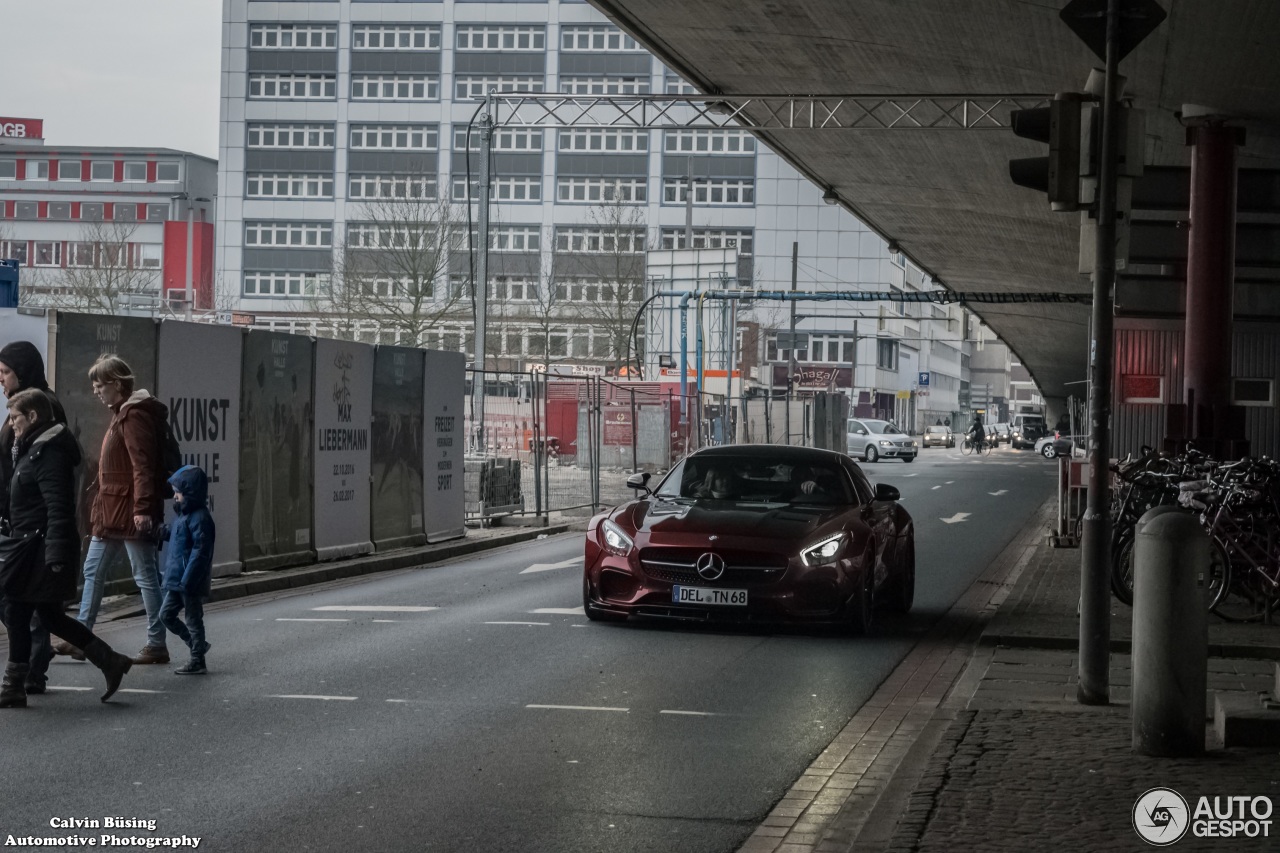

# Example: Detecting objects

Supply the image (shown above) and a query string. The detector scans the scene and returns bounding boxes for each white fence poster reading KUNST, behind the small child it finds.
[155,320,244,578]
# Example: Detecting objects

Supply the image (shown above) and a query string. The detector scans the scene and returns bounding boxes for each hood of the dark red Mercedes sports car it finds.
[616,500,858,543]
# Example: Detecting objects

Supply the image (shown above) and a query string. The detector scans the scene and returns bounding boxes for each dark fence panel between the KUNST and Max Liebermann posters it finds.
[241,329,315,570]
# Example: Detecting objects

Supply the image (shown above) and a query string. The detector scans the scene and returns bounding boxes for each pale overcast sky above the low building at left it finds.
[0,0,223,158]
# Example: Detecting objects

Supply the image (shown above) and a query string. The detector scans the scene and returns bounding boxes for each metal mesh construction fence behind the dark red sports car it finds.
[465,370,844,520]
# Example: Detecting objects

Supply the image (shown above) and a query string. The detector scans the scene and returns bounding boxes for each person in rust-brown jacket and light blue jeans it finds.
[54,355,169,663]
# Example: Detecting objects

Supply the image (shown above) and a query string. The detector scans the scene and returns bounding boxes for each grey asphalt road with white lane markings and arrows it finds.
[0,440,1056,853]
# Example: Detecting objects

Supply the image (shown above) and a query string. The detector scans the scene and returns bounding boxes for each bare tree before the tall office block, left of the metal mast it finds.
[320,183,467,346]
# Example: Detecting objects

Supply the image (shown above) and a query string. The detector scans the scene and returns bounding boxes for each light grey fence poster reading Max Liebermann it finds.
[314,338,374,560]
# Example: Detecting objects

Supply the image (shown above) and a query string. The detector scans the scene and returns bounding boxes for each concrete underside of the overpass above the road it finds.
[590,0,1280,407]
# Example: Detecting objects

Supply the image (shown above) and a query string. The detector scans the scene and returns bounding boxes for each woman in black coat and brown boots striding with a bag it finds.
[0,388,133,708]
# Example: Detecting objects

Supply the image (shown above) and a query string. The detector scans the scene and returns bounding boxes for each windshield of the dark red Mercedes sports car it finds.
[657,455,854,506]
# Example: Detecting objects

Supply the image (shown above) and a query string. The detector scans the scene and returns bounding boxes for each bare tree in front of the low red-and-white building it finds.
[24,222,160,314]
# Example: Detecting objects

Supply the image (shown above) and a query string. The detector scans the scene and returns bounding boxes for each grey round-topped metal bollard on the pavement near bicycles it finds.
[1130,506,1210,757]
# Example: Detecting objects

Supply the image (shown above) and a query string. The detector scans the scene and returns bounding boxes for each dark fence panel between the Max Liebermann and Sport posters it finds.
[370,346,426,551]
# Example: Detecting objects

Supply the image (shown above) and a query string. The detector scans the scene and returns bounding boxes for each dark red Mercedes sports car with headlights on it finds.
[582,444,915,634]
